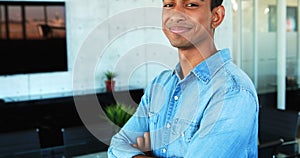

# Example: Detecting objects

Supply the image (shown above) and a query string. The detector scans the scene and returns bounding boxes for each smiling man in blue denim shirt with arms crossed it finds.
[108,0,259,158]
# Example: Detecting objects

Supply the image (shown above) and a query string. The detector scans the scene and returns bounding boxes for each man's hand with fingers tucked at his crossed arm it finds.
[132,132,152,156]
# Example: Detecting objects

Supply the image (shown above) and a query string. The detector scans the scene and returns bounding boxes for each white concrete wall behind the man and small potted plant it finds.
[0,0,232,101]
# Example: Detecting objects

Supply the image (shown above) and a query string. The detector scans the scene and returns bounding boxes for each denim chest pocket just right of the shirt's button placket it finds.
[172,118,199,143]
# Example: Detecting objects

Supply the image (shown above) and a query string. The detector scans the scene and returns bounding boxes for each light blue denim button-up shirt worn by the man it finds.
[108,49,259,158]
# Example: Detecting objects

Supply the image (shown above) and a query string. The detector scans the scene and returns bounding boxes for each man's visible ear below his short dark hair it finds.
[211,5,225,29]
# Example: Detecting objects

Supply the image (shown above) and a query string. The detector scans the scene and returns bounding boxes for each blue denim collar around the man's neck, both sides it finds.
[174,48,231,83]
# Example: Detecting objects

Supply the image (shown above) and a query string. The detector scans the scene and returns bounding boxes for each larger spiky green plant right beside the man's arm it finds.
[105,103,135,127]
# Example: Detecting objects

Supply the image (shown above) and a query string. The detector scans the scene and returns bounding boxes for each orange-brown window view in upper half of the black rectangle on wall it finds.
[0,2,66,39]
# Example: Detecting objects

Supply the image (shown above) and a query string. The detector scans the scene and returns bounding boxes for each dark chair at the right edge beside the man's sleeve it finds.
[259,107,298,157]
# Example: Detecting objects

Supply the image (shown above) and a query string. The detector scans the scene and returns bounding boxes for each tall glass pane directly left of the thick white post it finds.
[257,0,277,93]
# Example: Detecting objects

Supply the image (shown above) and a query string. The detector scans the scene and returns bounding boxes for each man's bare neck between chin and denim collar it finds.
[178,45,217,78]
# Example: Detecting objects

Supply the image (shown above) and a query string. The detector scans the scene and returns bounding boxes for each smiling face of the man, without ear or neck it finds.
[162,0,213,49]
